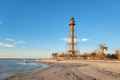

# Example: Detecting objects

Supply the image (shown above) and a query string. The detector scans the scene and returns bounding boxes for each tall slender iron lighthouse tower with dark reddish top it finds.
[68,17,77,57]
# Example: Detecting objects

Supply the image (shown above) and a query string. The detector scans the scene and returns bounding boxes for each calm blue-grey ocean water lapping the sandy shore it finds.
[0,59,47,80]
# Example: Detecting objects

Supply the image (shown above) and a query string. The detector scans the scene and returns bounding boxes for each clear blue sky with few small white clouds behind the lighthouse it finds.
[0,0,120,58]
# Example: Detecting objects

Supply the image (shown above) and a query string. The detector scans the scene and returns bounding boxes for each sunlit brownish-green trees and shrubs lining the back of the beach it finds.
[52,44,120,60]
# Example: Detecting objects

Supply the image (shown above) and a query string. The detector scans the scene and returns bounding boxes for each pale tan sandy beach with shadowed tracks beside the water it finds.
[8,60,120,80]
